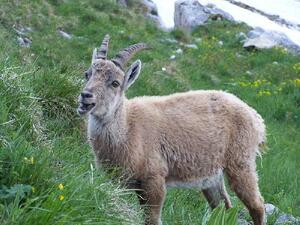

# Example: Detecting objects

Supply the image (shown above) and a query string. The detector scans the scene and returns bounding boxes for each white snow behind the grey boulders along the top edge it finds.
[153,0,300,46]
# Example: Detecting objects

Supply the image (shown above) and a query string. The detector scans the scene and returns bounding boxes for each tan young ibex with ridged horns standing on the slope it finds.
[78,35,265,225]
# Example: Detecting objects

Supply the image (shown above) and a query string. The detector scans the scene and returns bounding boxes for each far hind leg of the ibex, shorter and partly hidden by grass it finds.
[202,178,232,209]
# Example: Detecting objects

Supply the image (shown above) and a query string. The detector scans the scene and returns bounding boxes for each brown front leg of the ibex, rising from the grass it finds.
[140,176,166,225]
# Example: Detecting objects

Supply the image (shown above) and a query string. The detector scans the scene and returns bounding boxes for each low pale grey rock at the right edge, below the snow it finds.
[243,28,300,54]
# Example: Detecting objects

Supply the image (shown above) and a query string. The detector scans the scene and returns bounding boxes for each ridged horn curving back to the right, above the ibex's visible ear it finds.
[111,43,149,70]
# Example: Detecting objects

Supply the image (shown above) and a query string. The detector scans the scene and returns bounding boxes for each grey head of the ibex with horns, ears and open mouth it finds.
[77,35,148,117]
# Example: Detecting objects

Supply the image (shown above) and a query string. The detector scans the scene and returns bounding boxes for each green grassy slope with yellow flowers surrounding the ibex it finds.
[0,0,300,224]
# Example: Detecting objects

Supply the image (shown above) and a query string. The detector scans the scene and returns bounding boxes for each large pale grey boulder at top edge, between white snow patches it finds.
[174,0,233,31]
